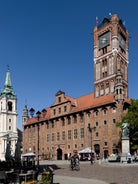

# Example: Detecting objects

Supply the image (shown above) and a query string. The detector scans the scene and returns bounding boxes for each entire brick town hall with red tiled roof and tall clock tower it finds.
[22,14,130,159]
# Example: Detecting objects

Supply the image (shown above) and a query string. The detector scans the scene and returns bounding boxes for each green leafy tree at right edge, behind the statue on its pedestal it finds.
[118,99,138,151]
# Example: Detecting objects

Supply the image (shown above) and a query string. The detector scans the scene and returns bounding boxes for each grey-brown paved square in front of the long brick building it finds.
[41,161,138,184]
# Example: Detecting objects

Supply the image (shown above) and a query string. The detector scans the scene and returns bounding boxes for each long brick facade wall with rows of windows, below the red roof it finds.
[24,98,128,159]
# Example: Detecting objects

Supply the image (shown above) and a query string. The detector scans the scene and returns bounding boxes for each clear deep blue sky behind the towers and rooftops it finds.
[0,0,138,128]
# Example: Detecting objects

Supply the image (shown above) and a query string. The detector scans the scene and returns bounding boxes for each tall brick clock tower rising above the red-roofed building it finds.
[93,14,129,101]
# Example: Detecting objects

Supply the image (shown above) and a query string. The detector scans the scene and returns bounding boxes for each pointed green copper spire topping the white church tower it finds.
[1,68,16,97]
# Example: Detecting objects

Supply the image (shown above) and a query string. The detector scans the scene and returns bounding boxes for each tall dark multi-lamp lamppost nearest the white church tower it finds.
[29,108,41,168]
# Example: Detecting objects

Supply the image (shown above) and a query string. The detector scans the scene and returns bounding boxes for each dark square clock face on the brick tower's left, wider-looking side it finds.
[98,31,110,49]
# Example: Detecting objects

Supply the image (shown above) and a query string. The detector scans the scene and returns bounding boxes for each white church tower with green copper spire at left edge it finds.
[0,68,18,160]
